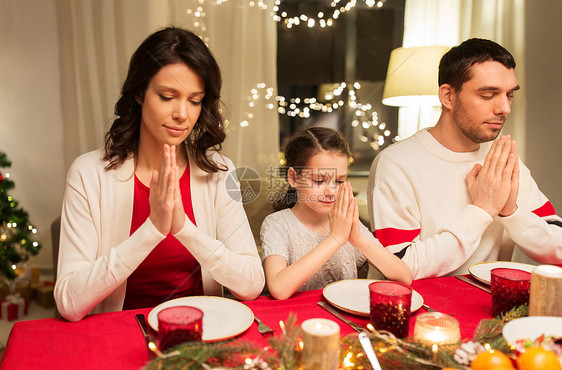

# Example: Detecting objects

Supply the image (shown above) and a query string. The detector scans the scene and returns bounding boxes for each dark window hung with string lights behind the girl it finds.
[277,0,405,172]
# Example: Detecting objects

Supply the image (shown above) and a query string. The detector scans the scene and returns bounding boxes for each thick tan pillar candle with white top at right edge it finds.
[529,265,562,316]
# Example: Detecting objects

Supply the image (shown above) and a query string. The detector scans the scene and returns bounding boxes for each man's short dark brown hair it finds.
[439,38,515,91]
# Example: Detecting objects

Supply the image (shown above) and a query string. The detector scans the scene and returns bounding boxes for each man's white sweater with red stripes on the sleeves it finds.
[367,129,562,279]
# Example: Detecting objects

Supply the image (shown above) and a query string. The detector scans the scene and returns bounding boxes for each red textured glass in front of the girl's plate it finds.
[369,281,412,338]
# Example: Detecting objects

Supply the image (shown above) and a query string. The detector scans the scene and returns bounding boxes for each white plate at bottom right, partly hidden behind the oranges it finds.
[502,316,562,345]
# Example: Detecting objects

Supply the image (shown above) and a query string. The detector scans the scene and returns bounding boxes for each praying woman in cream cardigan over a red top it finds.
[55,27,264,321]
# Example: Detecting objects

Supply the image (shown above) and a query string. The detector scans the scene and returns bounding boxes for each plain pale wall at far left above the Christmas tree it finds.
[0,0,65,268]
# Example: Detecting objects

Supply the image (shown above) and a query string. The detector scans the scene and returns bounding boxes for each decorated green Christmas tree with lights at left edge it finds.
[0,152,41,281]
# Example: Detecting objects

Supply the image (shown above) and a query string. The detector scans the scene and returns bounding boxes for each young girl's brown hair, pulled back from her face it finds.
[273,127,351,211]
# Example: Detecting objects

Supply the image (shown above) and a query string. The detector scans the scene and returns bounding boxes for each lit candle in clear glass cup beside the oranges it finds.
[414,312,461,345]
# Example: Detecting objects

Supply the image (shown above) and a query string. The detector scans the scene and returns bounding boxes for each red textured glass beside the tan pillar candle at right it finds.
[490,268,531,317]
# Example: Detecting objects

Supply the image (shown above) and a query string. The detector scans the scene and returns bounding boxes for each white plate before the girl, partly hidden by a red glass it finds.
[322,279,423,317]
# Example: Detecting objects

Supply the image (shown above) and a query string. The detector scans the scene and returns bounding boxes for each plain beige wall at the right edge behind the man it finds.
[522,0,562,211]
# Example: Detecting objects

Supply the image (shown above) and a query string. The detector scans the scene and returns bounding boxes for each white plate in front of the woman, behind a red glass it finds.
[148,296,254,342]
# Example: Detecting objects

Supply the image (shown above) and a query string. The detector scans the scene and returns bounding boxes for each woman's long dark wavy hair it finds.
[105,27,226,172]
